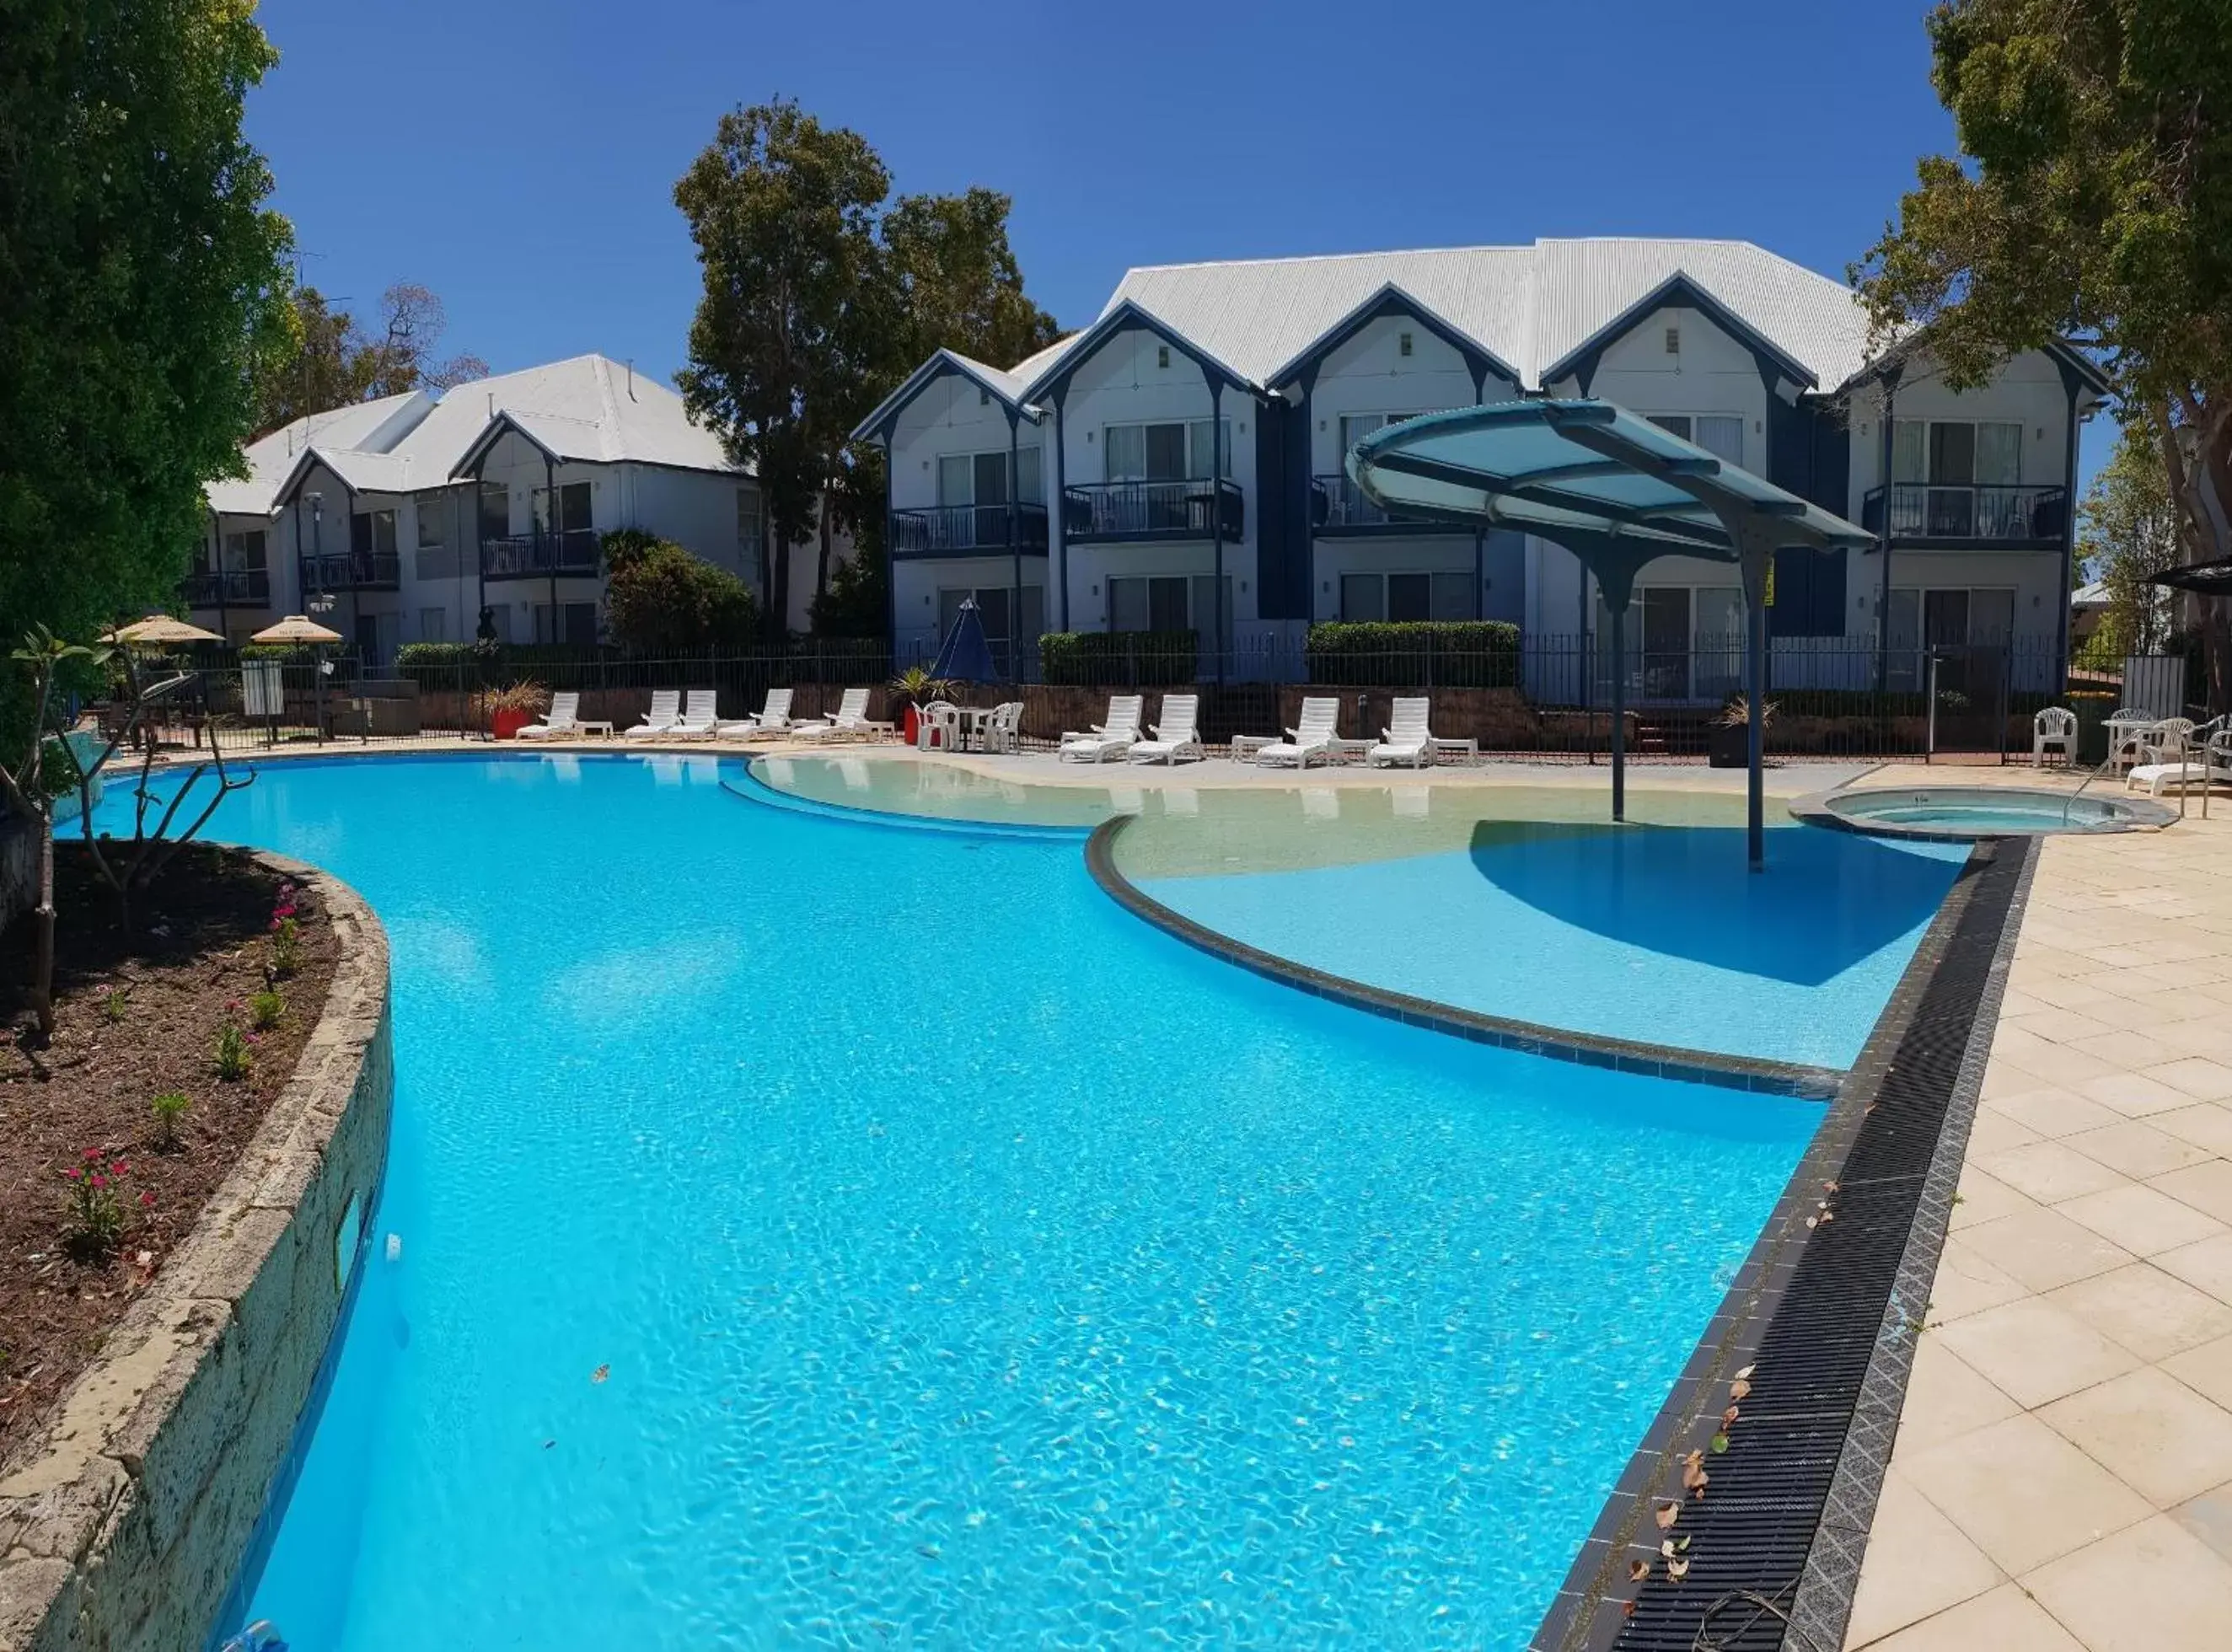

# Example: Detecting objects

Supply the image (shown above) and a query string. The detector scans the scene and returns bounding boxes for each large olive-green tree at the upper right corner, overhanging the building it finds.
[1854,0,2232,705]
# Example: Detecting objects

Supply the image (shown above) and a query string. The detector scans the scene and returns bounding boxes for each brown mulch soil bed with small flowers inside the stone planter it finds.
[0,844,335,1460]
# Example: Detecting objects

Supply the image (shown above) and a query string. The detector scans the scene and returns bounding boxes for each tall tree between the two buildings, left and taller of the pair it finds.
[674,100,891,636]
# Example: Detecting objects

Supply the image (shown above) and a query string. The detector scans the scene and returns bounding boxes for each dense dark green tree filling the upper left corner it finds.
[0,0,288,683]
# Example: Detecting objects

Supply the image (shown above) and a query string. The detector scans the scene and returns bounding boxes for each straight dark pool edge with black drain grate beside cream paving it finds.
[1532,839,2036,1652]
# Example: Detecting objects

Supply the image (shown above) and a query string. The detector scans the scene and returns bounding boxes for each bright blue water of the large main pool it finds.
[100,757,1828,1652]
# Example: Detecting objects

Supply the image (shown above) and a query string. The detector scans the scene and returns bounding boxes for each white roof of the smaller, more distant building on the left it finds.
[207,355,737,516]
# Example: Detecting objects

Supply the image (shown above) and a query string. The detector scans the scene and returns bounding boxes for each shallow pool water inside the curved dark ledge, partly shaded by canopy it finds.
[1119,819,1969,1067]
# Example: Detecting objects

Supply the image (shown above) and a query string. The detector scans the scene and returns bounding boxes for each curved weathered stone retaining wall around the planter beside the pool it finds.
[0,855,395,1652]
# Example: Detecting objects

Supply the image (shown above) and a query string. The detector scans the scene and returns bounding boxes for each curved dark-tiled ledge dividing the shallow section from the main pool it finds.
[1085,815,1846,1101]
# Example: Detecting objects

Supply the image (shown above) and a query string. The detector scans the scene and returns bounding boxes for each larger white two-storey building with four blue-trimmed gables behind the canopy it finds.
[857,239,2105,701]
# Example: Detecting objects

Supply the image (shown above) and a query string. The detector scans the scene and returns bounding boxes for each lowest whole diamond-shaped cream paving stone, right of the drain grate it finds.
[1899,1415,2152,1574]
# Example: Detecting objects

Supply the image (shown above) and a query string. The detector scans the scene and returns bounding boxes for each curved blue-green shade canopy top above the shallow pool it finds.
[1348,400,1875,560]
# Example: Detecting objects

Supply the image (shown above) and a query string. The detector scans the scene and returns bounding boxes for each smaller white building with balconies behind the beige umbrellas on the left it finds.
[185,355,813,665]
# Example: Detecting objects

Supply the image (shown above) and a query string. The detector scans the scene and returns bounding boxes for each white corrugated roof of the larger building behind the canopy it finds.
[1089,239,1868,391]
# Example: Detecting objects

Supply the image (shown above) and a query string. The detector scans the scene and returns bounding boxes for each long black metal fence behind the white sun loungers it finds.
[96,634,2197,761]
